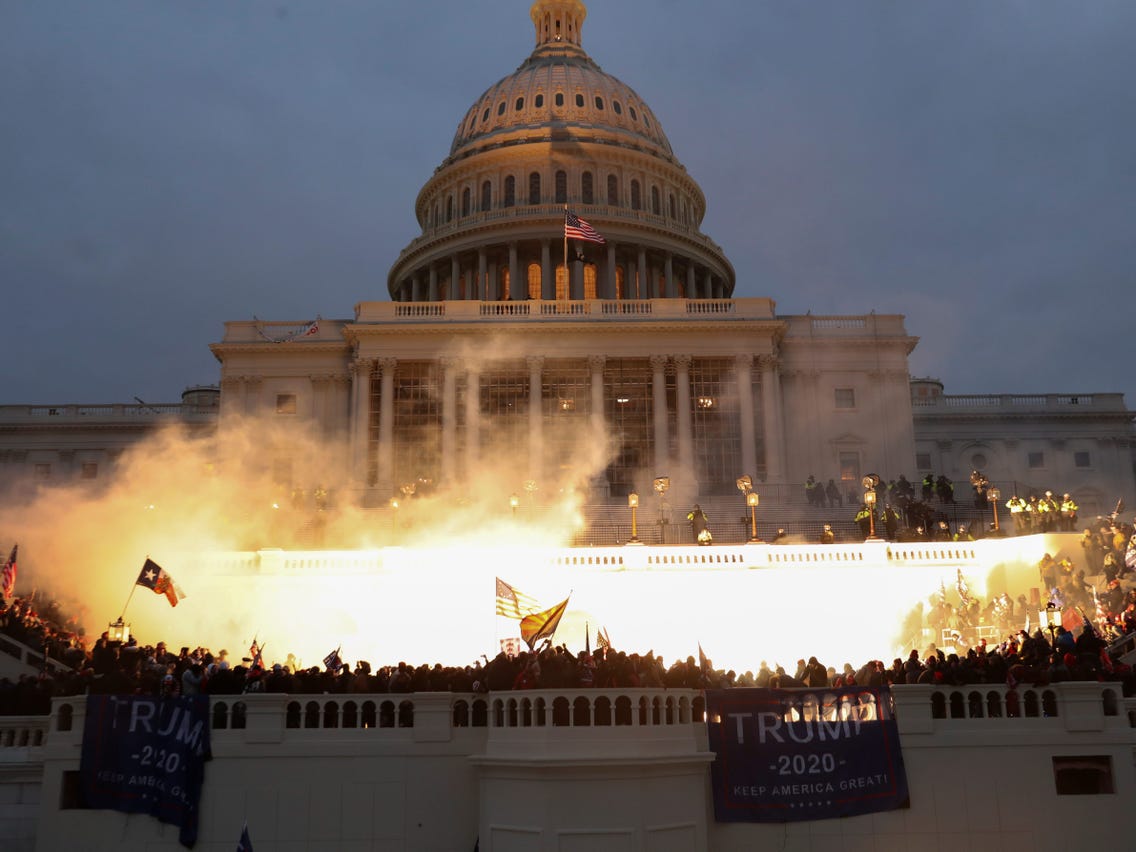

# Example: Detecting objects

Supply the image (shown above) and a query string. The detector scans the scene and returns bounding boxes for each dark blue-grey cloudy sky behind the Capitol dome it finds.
[0,0,1136,406]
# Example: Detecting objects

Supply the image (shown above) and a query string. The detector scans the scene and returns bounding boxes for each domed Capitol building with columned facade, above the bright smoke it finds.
[0,1,1136,513]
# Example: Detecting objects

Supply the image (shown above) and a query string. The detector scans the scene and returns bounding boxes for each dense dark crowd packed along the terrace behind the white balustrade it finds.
[0,531,1136,715]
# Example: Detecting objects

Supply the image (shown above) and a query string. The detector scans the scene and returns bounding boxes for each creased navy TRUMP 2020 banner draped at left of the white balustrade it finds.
[80,695,210,846]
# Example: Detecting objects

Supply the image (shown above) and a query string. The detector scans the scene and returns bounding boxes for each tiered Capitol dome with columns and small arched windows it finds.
[387,0,734,302]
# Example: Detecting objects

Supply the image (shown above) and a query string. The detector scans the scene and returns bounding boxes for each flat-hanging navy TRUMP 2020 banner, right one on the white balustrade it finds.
[707,686,908,822]
